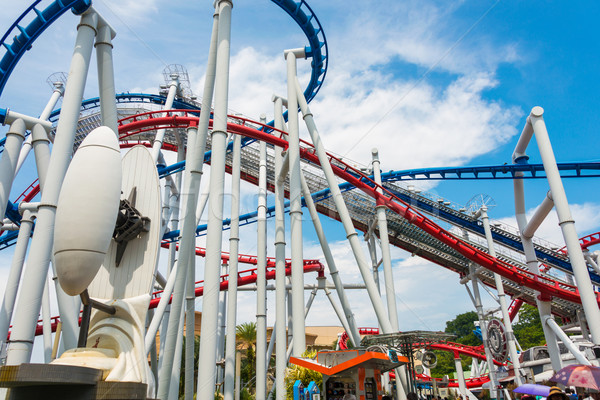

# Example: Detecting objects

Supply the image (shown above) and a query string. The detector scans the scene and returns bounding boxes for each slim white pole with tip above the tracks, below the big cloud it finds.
[371,149,400,331]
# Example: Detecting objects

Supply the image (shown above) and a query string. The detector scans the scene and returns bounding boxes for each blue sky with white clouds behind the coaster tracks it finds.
[0,0,600,360]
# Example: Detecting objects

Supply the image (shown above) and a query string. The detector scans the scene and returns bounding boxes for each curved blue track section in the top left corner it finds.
[0,0,92,95]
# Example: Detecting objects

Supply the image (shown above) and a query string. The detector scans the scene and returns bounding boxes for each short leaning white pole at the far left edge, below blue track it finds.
[0,119,26,219]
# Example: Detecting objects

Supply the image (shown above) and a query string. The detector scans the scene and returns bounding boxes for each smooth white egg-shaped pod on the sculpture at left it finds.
[54,126,122,299]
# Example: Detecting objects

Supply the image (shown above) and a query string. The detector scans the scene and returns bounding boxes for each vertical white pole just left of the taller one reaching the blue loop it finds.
[274,97,287,400]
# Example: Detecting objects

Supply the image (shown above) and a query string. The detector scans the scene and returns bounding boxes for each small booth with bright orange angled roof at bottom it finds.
[290,349,408,400]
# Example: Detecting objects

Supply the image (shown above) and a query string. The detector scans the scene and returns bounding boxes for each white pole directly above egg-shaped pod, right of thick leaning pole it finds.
[95,21,119,137]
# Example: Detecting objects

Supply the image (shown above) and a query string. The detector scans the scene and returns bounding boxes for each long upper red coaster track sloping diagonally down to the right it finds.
[113,110,596,303]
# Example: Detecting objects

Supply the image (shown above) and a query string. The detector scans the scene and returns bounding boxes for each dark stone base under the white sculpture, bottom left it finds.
[0,364,149,400]
